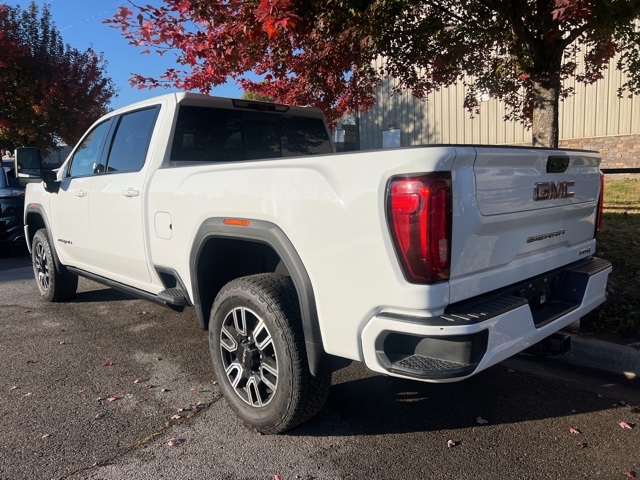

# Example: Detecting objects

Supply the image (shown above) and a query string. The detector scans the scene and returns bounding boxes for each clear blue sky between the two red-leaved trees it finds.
[3,0,242,108]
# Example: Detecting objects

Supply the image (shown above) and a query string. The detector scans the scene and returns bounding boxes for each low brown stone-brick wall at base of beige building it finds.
[560,135,640,168]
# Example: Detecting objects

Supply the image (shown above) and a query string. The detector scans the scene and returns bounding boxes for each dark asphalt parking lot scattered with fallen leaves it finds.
[0,256,640,480]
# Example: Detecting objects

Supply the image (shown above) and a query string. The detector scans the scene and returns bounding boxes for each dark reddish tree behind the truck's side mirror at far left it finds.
[0,1,116,148]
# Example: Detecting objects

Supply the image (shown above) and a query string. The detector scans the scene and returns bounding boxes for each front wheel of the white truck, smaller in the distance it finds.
[31,228,78,302]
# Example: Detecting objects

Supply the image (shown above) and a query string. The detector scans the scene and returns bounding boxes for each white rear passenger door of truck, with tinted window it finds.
[89,106,159,283]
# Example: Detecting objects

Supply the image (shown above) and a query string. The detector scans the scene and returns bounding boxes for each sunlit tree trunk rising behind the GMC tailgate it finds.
[531,75,560,148]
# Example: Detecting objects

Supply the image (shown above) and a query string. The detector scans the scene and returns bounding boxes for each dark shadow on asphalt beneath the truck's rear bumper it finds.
[289,364,628,436]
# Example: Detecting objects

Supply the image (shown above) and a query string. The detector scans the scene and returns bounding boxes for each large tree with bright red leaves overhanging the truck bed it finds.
[108,0,640,147]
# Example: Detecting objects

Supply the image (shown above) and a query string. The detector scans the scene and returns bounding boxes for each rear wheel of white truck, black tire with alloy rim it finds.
[209,273,331,433]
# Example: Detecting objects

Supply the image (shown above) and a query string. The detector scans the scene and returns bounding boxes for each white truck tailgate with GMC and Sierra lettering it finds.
[450,147,600,303]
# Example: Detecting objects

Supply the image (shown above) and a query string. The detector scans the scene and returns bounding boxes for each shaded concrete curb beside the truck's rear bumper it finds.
[554,335,640,379]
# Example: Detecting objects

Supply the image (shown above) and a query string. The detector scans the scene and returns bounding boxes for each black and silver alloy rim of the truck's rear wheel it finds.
[220,307,278,407]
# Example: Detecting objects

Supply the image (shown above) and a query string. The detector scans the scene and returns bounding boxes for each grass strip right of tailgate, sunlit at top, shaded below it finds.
[581,176,640,343]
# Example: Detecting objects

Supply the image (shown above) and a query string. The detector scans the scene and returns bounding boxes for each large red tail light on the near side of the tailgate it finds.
[387,172,451,284]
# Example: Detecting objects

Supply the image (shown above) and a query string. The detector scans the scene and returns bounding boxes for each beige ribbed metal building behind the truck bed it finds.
[359,59,640,168]
